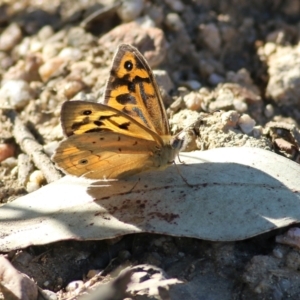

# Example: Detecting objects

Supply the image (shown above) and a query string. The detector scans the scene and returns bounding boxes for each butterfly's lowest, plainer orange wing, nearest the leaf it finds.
[53,132,174,179]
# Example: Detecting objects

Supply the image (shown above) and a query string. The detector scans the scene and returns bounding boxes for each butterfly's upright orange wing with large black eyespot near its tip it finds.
[104,44,170,135]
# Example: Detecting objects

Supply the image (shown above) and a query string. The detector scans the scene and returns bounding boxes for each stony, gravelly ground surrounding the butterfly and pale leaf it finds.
[0,0,300,300]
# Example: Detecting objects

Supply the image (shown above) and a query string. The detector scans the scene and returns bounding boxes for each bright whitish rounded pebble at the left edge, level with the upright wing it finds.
[0,80,32,109]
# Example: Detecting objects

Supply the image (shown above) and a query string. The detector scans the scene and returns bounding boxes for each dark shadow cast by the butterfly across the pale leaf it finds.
[87,150,300,241]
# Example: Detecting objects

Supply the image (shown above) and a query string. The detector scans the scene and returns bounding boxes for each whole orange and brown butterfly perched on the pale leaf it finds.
[53,44,182,179]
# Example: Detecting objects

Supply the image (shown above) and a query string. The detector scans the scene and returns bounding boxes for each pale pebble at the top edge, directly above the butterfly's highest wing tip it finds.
[117,0,145,22]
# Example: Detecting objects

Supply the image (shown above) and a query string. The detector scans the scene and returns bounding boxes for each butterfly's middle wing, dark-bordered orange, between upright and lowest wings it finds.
[61,101,162,146]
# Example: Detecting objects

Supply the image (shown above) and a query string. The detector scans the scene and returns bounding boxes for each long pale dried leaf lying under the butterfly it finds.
[0,148,300,251]
